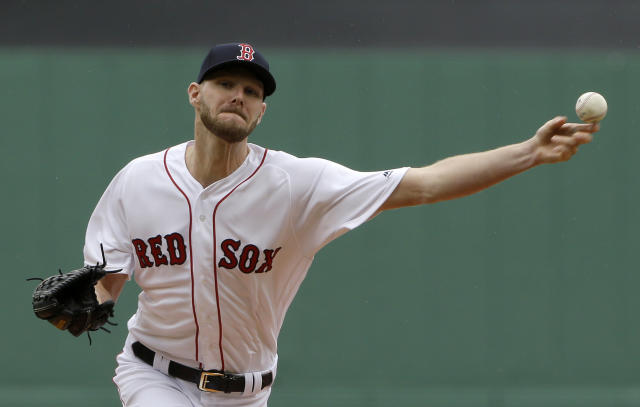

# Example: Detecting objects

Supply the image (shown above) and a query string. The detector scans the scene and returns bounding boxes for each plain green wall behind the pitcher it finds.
[0,48,640,407]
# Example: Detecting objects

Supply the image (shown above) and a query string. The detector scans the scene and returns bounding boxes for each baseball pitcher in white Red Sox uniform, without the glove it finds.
[79,43,598,407]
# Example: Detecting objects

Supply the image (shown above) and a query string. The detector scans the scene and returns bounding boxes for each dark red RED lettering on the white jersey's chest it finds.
[131,233,187,268]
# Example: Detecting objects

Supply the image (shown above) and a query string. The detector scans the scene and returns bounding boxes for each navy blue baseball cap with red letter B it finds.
[198,43,276,97]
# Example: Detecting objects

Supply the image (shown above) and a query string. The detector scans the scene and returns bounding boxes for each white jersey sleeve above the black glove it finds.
[84,166,135,278]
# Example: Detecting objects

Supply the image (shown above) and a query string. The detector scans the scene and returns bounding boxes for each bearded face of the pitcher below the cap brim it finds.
[196,68,266,143]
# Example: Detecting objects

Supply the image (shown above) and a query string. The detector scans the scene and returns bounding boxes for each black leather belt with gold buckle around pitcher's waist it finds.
[131,342,273,393]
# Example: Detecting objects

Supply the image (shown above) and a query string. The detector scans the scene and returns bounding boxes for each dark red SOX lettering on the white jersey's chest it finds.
[218,239,282,274]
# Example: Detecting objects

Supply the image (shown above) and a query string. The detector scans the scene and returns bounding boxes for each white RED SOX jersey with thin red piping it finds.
[84,141,407,373]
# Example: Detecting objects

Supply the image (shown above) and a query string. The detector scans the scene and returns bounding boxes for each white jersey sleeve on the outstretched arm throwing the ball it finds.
[291,158,408,257]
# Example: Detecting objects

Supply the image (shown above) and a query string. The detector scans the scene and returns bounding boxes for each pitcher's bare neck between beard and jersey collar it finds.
[185,133,249,188]
